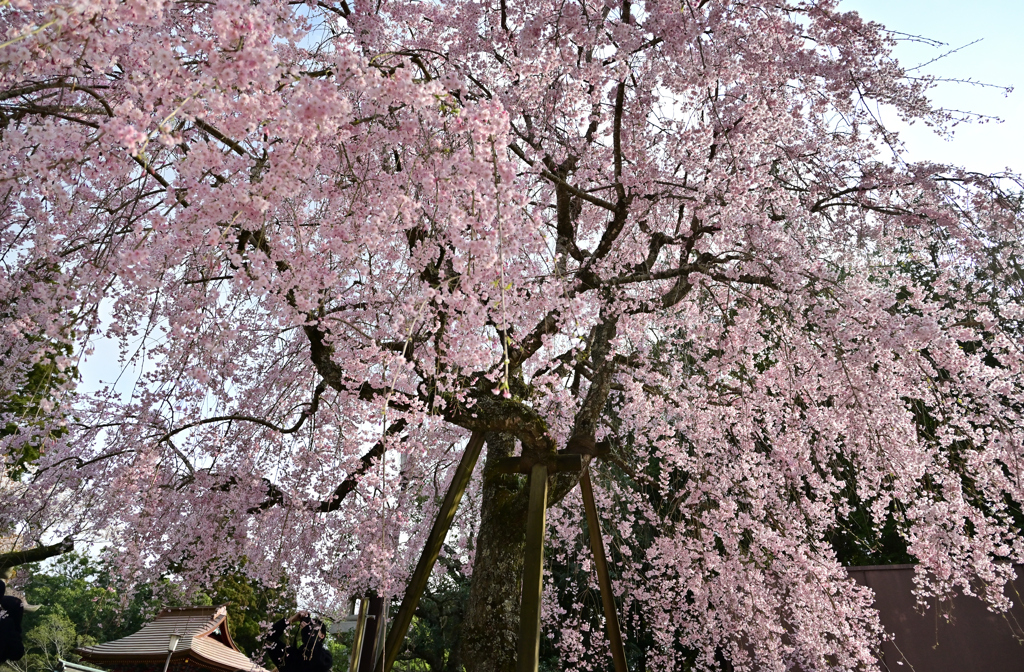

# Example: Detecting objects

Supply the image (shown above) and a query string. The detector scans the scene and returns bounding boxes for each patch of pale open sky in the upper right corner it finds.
[840,0,1024,172]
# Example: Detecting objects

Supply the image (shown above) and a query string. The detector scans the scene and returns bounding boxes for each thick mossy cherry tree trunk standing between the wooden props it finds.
[462,433,529,672]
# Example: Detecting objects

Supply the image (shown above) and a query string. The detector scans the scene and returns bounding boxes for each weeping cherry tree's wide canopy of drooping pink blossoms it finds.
[0,0,1024,672]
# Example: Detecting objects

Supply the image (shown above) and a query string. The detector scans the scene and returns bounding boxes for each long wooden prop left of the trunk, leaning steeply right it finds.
[383,431,483,672]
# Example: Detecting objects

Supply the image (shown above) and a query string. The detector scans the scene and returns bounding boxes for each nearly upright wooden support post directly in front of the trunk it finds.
[516,463,548,672]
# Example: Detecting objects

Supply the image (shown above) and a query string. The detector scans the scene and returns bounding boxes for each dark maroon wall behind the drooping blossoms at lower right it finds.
[849,564,1024,672]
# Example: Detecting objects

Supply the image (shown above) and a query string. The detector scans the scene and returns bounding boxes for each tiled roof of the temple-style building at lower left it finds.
[78,606,266,672]
